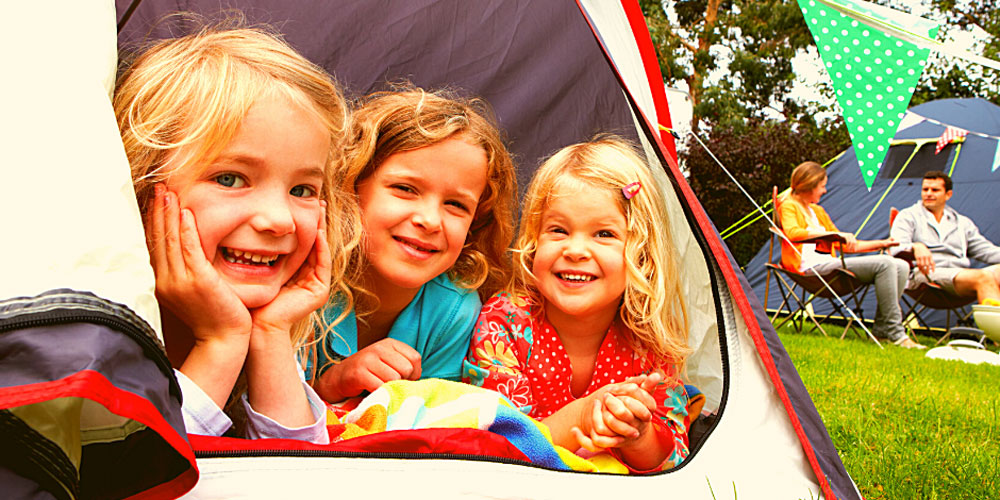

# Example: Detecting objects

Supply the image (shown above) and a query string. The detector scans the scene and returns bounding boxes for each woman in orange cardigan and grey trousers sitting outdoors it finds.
[778,161,925,349]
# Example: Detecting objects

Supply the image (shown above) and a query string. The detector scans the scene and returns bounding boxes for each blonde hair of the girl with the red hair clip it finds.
[509,136,690,370]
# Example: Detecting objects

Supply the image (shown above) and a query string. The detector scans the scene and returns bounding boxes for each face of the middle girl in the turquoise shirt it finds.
[357,136,487,295]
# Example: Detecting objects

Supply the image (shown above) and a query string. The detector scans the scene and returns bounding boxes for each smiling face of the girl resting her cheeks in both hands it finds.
[166,91,330,309]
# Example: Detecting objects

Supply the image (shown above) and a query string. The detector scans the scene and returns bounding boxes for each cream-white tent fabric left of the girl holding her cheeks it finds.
[0,0,160,332]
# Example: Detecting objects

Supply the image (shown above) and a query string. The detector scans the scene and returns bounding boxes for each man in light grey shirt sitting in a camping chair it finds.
[889,170,1000,305]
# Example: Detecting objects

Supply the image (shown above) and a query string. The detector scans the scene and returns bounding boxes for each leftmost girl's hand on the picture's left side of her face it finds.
[148,184,251,344]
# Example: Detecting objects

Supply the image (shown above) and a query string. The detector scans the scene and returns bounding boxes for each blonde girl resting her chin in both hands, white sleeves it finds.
[114,28,353,443]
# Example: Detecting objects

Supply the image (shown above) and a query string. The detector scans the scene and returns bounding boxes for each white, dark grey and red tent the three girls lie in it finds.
[0,0,860,499]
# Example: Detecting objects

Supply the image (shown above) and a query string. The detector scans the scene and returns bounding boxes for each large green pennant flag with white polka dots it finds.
[798,0,938,190]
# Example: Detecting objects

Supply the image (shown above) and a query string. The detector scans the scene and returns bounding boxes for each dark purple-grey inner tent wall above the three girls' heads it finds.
[117,0,636,190]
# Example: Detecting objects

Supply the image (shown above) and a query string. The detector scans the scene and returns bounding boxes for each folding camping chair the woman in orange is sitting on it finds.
[764,187,870,338]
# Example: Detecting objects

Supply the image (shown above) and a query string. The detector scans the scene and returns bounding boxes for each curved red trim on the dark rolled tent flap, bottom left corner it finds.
[0,370,198,499]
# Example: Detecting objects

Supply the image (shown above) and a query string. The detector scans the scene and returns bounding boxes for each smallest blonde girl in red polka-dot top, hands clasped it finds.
[463,137,690,471]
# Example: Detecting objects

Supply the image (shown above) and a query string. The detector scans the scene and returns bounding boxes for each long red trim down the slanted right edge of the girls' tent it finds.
[577,4,837,500]
